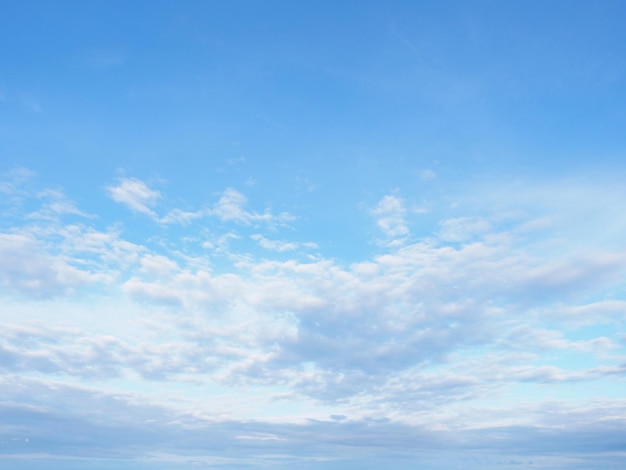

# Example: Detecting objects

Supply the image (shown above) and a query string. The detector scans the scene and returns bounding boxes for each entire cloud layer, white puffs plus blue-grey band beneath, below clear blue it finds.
[0,170,626,468]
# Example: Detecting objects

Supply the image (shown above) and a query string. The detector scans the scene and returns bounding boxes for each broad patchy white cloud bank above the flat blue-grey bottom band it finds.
[0,173,626,470]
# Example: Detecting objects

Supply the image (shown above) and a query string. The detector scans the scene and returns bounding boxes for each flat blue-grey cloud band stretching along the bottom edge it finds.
[0,377,626,470]
